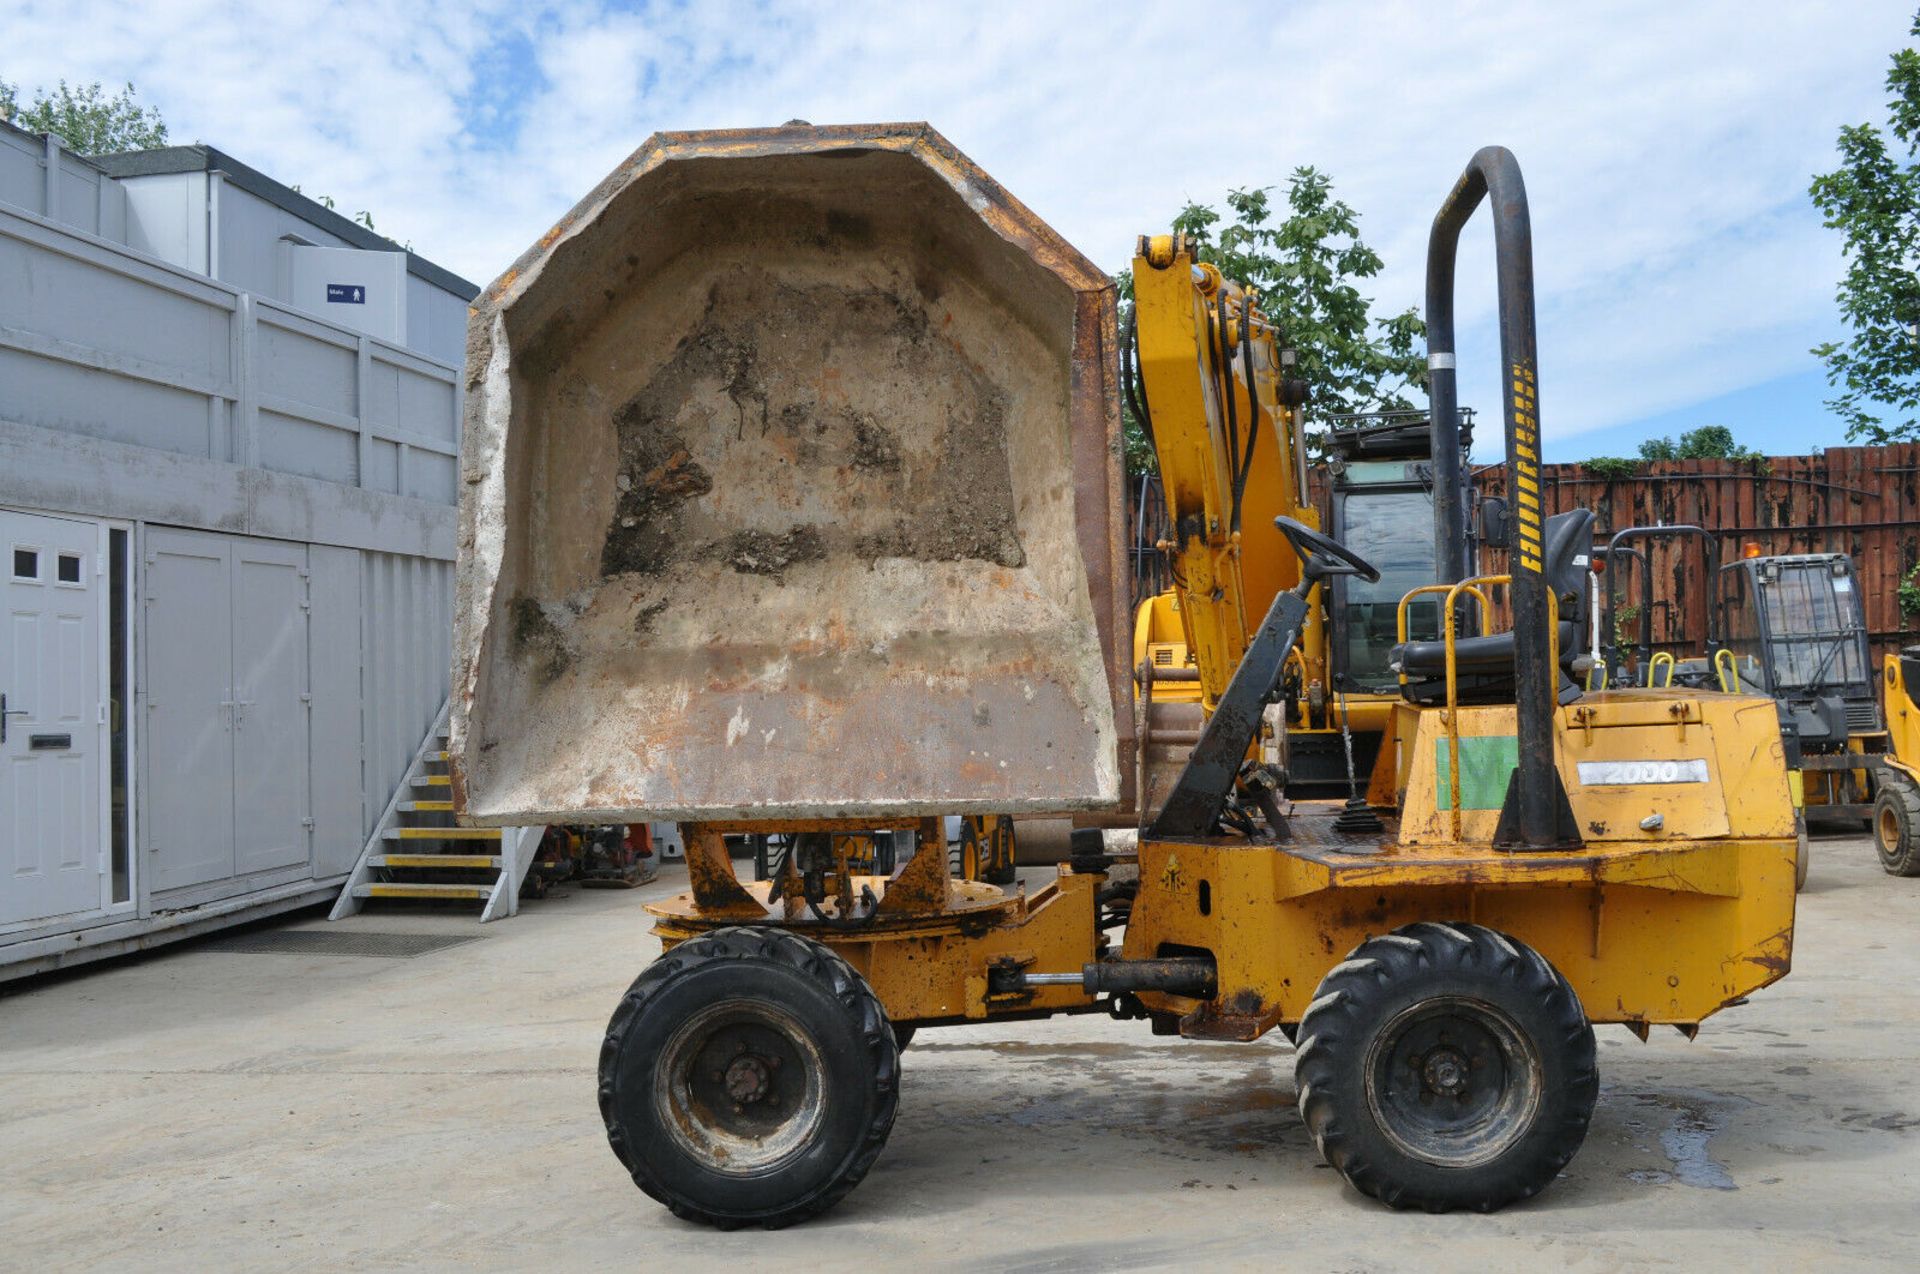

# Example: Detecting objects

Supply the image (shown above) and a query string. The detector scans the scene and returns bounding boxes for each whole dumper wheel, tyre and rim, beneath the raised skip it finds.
[599,927,900,1230]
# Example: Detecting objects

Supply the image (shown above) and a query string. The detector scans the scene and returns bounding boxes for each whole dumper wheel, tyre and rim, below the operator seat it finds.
[1294,923,1599,1213]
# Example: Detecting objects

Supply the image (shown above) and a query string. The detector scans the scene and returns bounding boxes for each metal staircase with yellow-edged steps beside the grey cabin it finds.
[328,704,541,921]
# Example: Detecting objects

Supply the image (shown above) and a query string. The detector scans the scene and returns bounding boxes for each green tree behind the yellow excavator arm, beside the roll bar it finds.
[1117,167,1427,472]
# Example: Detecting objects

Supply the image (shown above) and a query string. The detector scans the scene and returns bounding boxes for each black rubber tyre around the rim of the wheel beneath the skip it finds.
[599,927,900,1230]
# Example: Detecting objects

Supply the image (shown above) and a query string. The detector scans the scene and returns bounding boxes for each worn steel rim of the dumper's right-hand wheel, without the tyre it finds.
[1363,996,1546,1168]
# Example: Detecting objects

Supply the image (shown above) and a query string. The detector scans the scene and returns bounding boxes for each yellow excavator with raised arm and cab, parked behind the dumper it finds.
[1123,234,1438,825]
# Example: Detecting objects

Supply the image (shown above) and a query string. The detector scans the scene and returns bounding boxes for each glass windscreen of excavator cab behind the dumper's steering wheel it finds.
[1334,491,1440,691]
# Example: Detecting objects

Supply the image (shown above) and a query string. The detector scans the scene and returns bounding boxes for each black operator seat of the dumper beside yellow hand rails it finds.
[1388,508,1594,706]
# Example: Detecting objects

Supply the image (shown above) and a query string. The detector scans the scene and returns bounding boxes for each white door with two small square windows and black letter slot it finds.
[0,512,106,925]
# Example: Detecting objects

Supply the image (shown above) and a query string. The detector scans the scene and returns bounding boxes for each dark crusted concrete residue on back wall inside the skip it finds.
[601,269,1025,581]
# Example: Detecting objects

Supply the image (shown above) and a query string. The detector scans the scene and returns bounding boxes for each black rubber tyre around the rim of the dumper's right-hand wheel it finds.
[1294,921,1599,1213]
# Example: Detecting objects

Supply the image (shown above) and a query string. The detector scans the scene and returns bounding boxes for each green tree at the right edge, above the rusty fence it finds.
[1809,13,1920,443]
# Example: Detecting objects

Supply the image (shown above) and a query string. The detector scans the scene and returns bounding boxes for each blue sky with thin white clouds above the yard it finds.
[0,0,1912,459]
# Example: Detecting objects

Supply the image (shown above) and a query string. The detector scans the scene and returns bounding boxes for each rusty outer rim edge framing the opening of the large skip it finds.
[447,123,1137,823]
